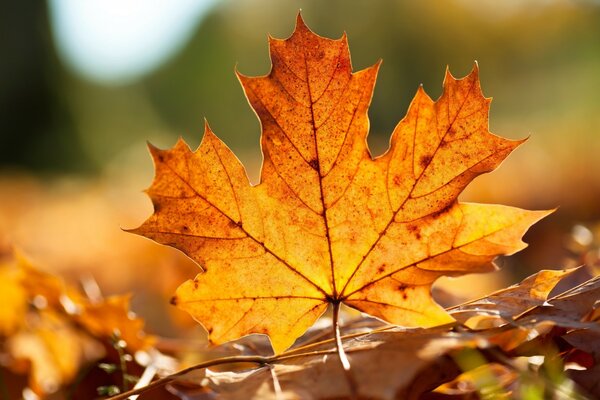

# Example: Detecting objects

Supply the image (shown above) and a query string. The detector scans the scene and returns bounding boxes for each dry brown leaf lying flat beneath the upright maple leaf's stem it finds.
[175,330,484,400]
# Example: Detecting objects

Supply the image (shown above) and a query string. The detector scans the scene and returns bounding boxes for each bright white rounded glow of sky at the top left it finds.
[48,0,215,83]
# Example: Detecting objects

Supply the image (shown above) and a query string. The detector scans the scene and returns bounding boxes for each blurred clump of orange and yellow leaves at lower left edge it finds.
[0,252,154,398]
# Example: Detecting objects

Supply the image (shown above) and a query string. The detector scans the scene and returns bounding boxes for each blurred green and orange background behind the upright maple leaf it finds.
[0,0,600,335]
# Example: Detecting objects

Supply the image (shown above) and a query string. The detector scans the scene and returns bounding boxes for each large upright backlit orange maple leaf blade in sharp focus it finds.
[132,16,548,353]
